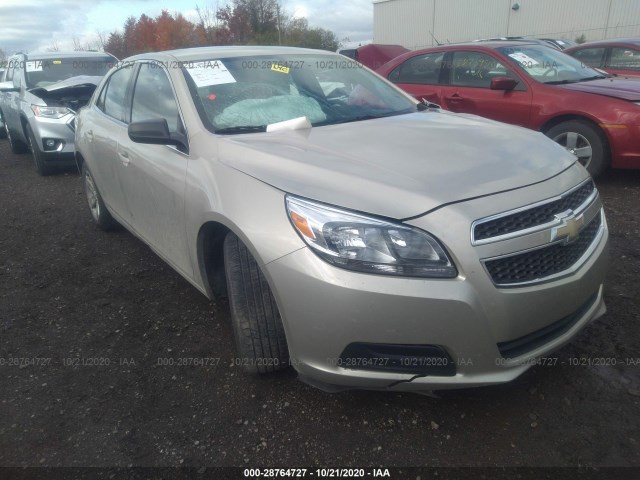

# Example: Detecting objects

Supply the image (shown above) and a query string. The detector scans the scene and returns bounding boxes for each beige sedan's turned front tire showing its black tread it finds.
[223,233,289,374]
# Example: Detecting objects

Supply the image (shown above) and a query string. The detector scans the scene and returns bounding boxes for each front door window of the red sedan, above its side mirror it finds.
[450,52,520,90]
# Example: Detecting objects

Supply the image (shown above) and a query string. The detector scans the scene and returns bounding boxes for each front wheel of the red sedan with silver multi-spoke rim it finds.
[546,120,610,177]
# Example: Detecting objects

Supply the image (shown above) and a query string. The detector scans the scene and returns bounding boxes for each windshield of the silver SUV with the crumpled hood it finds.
[25,57,115,88]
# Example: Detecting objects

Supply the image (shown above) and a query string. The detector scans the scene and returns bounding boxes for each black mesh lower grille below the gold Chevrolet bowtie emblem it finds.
[485,213,602,285]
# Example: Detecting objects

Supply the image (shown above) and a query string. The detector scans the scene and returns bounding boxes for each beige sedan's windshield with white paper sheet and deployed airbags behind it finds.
[184,55,416,133]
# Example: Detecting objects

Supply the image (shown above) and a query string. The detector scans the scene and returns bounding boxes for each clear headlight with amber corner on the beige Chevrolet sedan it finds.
[286,196,458,278]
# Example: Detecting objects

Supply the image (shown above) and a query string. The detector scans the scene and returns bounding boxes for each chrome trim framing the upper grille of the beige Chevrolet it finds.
[471,178,598,246]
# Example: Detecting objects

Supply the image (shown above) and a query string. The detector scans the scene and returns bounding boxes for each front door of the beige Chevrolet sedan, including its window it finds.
[118,63,193,278]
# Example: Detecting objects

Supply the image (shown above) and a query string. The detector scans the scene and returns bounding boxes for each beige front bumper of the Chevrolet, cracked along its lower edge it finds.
[264,165,608,391]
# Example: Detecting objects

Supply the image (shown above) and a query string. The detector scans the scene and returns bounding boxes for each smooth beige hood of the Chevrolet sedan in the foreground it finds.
[219,111,575,219]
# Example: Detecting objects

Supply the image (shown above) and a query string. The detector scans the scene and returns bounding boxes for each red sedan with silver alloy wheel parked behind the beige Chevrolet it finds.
[377,42,640,176]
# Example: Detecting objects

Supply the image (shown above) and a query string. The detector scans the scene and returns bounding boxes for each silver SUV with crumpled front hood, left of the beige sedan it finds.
[0,52,117,175]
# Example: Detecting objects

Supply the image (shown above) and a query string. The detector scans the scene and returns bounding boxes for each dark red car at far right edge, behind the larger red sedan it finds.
[564,38,640,78]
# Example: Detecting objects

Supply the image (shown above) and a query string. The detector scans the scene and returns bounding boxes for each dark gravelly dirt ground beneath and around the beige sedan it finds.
[0,140,640,480]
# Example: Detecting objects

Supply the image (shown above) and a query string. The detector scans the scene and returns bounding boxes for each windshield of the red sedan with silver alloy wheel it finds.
[498,45,604,85]
